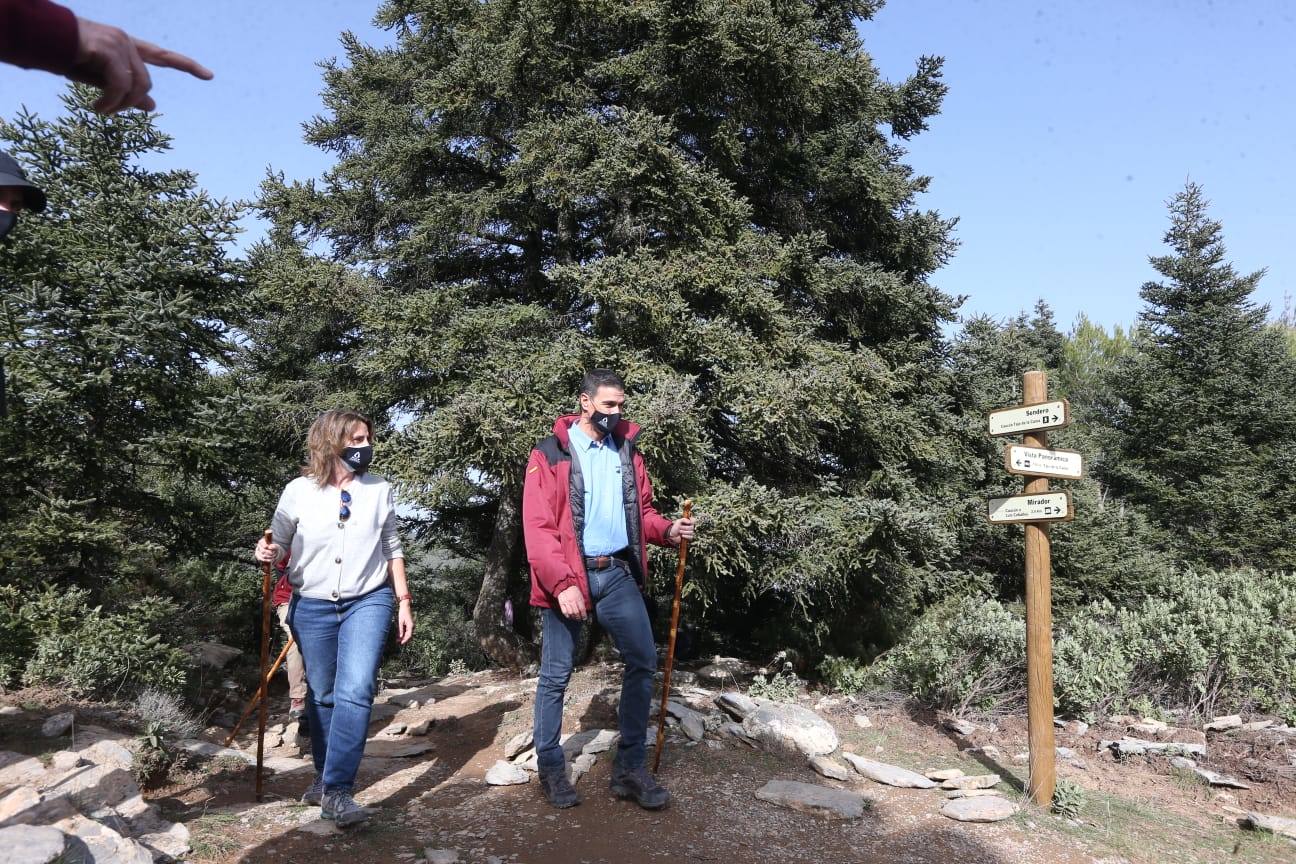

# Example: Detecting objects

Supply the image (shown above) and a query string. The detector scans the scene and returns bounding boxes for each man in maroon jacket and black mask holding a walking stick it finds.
[522,369,693,810]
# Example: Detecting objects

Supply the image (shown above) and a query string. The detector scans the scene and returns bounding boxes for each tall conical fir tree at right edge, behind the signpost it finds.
[1105,184,1296,567]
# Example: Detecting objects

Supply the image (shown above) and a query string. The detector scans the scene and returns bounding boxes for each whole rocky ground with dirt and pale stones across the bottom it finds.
[0,655,1296,864]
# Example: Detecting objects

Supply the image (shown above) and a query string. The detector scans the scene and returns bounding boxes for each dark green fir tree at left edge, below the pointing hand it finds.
[0,88,254,596]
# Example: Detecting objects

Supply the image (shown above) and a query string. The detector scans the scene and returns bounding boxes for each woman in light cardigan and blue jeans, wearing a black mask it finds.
[257,411,413,825]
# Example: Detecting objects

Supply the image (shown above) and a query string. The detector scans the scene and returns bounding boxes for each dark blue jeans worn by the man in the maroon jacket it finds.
[534,561,657,772]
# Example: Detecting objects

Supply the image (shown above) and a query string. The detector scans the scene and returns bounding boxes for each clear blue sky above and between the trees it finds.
[0,0,1296,326]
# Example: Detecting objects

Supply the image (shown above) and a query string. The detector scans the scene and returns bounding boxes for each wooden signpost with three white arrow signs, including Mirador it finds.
[986,372,1085,807]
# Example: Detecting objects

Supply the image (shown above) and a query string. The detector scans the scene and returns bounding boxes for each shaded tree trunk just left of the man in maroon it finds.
[473,486,535,668]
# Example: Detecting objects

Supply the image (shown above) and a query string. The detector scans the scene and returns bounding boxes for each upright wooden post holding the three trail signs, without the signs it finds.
[1021,372,1058,807]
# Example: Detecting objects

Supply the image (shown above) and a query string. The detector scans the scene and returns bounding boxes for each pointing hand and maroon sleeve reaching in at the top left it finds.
[0,0,211,114]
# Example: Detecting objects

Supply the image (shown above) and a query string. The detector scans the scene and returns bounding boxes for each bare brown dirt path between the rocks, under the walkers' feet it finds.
[128,667,1292,864]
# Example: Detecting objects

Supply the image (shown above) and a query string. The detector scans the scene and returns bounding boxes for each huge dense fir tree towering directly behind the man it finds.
[247,0,971,662]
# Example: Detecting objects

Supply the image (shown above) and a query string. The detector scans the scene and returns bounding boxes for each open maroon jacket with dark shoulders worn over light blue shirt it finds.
[522,415,671,608]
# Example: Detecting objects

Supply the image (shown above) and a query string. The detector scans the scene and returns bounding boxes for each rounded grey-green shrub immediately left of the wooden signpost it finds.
[875,597,1026,714]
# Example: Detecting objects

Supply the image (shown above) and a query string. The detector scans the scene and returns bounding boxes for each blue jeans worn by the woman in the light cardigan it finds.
[288,585,397,791]
